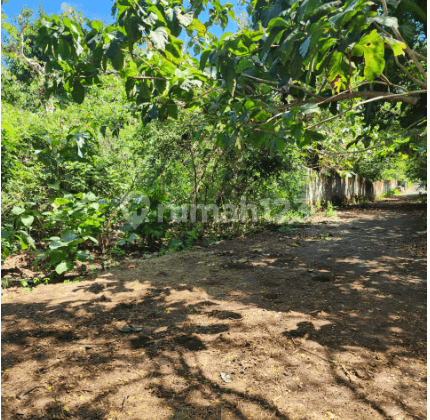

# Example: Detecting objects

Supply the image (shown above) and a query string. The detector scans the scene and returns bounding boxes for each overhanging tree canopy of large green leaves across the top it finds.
[8,0,427,150]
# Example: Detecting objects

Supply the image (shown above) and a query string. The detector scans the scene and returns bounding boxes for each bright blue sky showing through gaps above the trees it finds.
[2,0,237,37]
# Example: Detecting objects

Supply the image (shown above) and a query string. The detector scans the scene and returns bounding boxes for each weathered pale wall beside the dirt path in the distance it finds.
[306,169,397,205]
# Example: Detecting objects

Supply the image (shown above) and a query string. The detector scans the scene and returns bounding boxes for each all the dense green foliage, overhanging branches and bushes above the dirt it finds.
[2,0,427,282]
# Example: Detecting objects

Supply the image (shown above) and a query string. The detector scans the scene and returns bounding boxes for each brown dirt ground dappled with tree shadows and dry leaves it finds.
[1,190,427,420]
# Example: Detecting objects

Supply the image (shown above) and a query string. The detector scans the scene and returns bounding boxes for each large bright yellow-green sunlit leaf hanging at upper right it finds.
[351,29,385,82]
